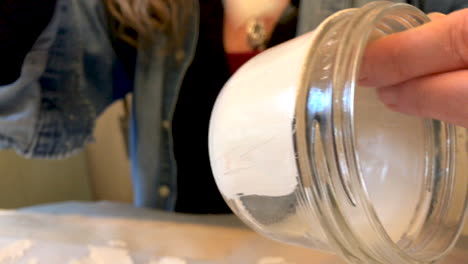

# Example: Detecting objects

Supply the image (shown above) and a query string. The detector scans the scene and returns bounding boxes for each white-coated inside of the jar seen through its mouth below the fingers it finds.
[354,87,427,241]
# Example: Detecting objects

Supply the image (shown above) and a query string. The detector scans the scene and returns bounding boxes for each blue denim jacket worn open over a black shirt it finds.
[0,0,466,210]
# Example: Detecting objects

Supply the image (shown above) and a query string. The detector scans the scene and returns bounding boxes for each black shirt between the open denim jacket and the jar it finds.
[172,0,297,214]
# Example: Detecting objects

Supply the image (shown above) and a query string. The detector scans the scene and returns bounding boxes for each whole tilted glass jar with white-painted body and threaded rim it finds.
[209,1,468,264]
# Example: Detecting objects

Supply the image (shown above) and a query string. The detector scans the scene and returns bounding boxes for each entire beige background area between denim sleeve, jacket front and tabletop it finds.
[0,101,133,209]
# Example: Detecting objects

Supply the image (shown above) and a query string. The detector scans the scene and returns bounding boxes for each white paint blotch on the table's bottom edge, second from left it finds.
[68,246,133,264]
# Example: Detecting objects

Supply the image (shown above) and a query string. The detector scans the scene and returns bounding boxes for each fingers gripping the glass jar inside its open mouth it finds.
[360,9,468,128]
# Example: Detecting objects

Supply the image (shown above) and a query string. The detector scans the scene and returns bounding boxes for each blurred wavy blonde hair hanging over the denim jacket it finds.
[104,0,188,46]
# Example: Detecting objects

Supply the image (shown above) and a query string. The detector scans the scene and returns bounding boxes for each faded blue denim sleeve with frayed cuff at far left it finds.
[0,0,115,158]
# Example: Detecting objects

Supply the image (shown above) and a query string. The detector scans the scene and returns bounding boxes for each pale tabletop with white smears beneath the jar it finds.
[0,202,468,264]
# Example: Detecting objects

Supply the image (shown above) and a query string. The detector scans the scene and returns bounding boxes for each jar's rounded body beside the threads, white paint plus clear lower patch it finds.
[209,20,336,250]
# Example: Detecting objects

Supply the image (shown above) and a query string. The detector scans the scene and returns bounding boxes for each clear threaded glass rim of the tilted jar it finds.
[293,1,464,263]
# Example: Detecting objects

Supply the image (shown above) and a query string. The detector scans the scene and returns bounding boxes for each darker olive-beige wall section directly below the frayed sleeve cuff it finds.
[0,148,93,208]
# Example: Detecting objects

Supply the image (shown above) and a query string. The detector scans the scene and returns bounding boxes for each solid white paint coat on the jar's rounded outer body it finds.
[209,28,314,198]
